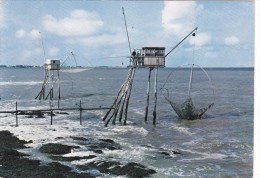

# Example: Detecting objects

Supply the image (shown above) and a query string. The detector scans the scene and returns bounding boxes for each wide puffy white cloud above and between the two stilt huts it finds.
[42,10,103,36]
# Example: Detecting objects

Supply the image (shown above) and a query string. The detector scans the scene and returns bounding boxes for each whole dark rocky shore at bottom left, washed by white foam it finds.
[0,131,156,178]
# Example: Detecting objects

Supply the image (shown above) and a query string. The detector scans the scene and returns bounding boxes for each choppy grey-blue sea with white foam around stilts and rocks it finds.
[0,68,254,177]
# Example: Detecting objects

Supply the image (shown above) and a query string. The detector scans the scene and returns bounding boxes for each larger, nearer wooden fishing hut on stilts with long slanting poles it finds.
[103,8,198,126]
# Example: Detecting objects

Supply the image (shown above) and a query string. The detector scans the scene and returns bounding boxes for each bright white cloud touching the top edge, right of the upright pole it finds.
[162,1,203,37]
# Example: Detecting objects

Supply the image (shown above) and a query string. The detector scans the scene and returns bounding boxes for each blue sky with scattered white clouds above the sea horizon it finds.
[0,0,255,67]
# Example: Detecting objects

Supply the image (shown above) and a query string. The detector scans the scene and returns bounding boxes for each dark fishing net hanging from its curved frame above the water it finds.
[161,64,214,120]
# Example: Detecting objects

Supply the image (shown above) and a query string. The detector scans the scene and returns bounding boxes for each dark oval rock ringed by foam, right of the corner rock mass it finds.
[39,143,80,155]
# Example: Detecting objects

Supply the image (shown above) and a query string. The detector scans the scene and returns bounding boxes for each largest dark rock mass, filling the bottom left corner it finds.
[0,131,94,178]
